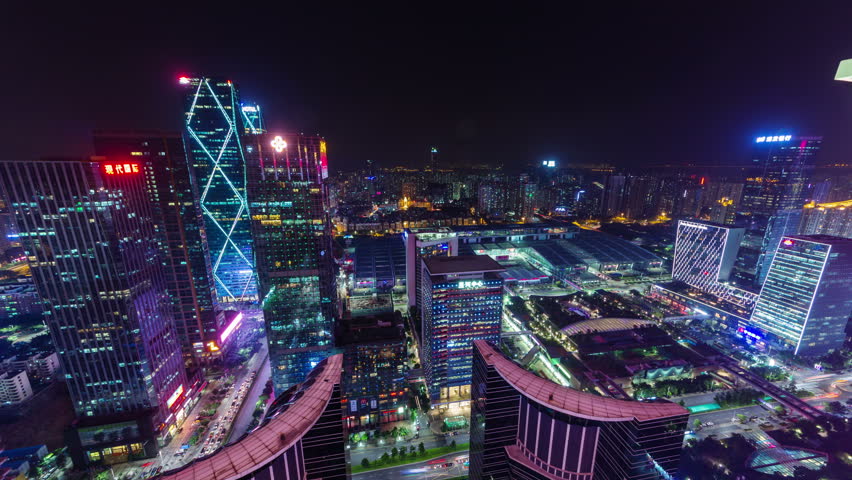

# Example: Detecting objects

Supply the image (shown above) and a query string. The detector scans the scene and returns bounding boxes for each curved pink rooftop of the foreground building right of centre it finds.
[474,340,689,422]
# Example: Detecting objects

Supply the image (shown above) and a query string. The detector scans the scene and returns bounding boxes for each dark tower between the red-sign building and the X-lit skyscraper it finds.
[94,131,224,361]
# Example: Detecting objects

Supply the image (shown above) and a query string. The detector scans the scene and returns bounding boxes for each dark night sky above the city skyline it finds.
[0,1,852,169]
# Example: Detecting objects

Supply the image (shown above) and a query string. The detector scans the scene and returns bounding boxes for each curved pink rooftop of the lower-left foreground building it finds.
[156,354,343,480]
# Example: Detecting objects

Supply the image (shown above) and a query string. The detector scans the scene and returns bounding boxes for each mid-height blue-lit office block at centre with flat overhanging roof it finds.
[418,255,505,404]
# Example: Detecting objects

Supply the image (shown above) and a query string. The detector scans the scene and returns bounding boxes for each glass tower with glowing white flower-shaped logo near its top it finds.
[245,134,336,393]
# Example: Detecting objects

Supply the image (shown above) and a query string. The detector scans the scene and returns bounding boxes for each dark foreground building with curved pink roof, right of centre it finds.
[470,340,689,480]
